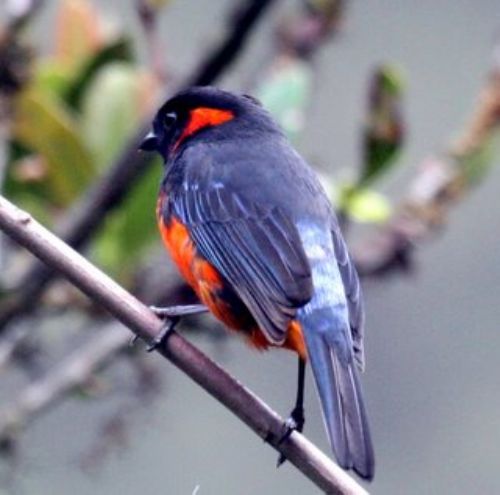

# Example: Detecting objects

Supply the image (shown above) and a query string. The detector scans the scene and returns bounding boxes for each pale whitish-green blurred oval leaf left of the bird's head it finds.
[82,62,154,169]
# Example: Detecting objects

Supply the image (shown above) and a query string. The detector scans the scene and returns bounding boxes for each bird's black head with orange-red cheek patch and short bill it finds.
[139,86,277,161]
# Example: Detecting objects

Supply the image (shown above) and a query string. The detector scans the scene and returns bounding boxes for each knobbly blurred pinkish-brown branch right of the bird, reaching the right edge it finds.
[352,55,500,277]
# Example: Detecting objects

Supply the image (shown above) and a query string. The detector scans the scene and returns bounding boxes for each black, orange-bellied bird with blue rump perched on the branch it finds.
[141,87,374,479]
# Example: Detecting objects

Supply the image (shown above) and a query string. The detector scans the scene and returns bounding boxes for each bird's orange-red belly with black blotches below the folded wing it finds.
[157,209,306,359]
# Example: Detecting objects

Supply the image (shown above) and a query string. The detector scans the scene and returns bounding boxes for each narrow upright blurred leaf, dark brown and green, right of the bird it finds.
[358,65,404,186]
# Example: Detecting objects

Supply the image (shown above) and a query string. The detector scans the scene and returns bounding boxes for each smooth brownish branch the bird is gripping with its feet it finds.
[0,196,366,494]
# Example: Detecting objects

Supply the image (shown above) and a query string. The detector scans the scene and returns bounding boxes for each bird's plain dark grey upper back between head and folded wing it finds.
[171,136,332,218]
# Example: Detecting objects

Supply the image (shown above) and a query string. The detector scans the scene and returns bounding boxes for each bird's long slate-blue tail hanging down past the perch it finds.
[299,307,375,480]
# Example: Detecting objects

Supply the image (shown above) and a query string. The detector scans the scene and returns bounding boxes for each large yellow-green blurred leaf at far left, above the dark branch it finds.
[13,88,94,206]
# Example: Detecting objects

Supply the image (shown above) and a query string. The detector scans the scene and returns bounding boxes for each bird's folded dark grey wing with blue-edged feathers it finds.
[170,184,313,344]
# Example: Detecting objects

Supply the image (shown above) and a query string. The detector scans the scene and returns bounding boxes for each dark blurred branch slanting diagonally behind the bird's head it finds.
[0,0,276,333]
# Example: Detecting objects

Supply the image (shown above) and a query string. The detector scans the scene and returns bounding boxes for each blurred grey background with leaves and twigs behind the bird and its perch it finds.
[0,0,500,495]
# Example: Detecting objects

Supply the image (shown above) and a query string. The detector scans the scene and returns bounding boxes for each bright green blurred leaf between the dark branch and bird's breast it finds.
[92,159,162,284]
